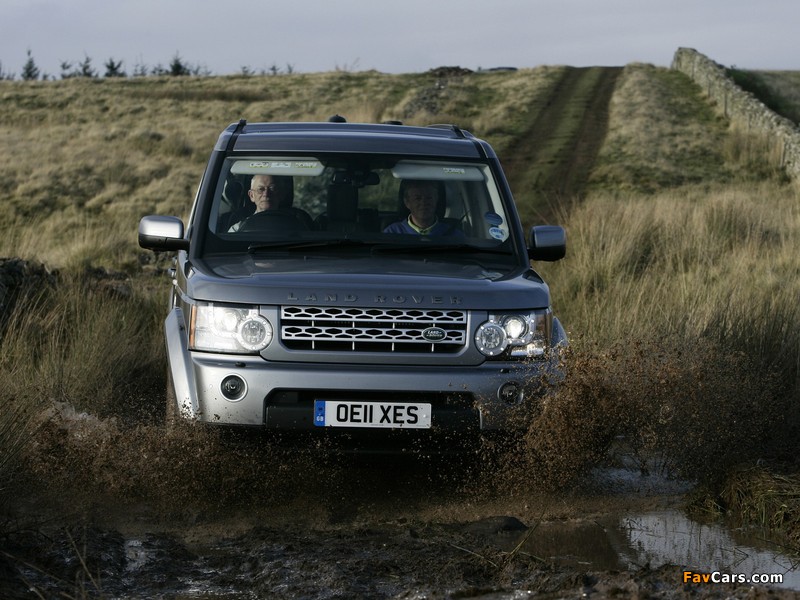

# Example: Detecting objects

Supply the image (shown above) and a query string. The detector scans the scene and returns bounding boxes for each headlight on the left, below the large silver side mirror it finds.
[189,303,272,354]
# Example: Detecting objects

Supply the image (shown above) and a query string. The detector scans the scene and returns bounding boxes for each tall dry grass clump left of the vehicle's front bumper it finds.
[0,271,165,416]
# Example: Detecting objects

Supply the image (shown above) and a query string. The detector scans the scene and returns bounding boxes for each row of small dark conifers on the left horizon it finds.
[0,50,294,81]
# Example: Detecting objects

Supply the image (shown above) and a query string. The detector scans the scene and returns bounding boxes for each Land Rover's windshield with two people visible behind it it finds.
[203,156,515,262]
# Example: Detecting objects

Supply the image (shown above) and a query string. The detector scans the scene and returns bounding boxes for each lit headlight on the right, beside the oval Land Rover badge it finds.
[475,309,553,358]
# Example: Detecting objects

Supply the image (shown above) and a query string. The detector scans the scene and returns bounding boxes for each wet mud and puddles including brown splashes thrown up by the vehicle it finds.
[0,338,800,599]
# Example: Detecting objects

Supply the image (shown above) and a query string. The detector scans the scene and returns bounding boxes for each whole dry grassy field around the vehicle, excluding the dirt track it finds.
[0,64,800,540]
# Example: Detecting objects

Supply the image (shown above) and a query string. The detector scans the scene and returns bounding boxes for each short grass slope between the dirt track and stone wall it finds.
[590,64,782,193]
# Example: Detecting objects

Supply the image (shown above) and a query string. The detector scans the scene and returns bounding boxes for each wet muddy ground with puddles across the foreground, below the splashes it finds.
[7,465,800,599]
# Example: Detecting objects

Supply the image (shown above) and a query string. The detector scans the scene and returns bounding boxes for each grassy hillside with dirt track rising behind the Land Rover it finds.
[0,55,788,268]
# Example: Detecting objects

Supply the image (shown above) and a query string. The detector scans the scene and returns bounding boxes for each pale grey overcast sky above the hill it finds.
[0,0,800,76]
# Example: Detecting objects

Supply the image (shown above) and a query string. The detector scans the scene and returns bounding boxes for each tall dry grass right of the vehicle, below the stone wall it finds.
[515,181,800,516]
